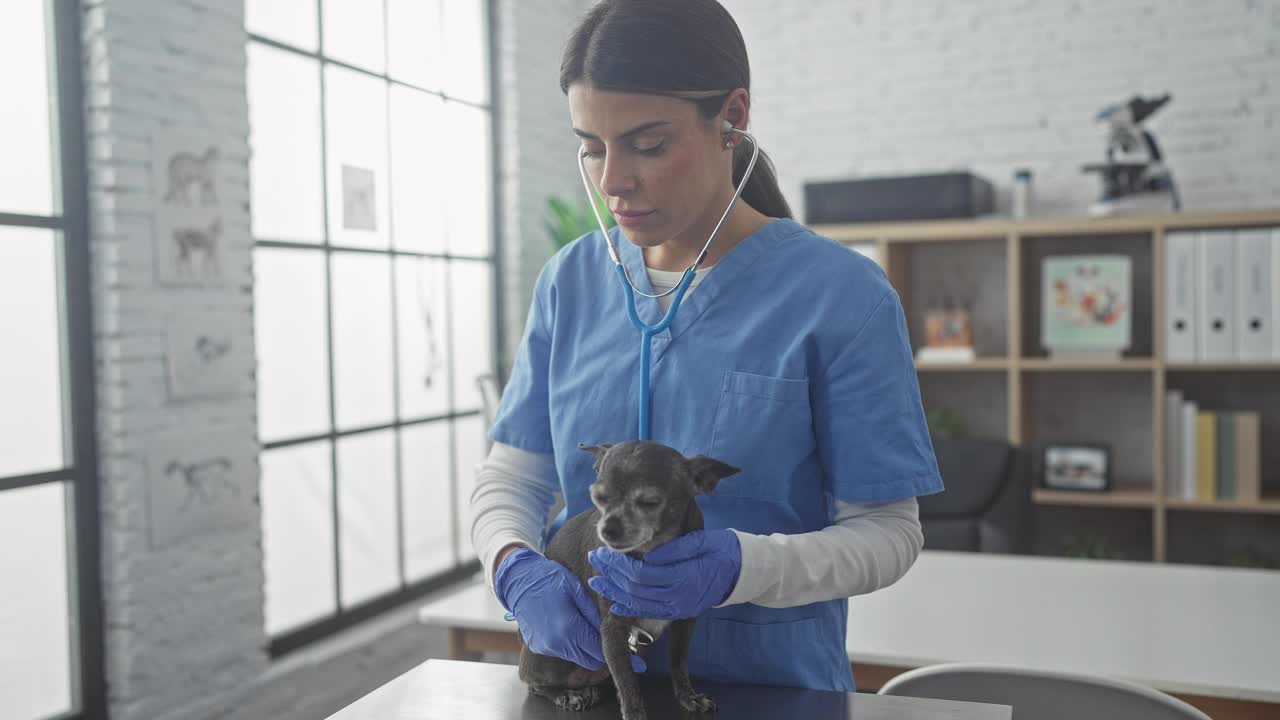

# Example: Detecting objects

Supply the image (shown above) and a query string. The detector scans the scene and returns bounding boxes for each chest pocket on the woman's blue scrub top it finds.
[707,370,814,502]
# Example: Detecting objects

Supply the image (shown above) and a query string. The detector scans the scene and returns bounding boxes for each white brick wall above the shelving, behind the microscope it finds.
[723,0,1280,217]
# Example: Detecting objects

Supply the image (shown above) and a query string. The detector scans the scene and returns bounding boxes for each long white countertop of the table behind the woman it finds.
[419,551,1280,703]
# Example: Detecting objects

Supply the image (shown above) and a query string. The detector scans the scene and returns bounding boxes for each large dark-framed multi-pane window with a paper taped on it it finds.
[246,0,497,653]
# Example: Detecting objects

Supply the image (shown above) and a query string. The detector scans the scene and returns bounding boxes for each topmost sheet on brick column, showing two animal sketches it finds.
[151,132,225,284]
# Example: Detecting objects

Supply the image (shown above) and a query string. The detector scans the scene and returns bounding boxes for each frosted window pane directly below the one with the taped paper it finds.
[332,252,396,429]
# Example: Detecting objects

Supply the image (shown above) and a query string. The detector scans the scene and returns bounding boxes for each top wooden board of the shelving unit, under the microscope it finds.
[812,210,1280,242]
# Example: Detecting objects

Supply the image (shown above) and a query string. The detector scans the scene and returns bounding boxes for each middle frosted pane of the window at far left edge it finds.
[0,229,64,477]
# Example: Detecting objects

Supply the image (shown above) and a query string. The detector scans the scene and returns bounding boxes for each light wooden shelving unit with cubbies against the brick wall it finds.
[814,210,1280,562]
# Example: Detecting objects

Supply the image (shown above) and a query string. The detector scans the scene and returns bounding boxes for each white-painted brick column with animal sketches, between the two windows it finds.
[83,0,268,720]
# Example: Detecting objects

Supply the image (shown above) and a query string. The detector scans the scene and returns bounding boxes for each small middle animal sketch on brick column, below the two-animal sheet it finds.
[168,310,243,400]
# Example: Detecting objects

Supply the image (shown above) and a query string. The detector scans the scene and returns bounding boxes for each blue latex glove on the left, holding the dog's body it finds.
[494,547,645,673]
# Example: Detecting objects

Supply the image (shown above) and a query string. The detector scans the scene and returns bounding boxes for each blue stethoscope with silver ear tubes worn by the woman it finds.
[577,120,760,439]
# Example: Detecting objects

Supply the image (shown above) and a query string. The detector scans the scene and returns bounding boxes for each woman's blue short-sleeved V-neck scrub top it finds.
[490,219,942,692]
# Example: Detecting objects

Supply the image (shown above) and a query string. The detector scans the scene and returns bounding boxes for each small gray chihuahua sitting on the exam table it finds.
[520,441,739,720]
